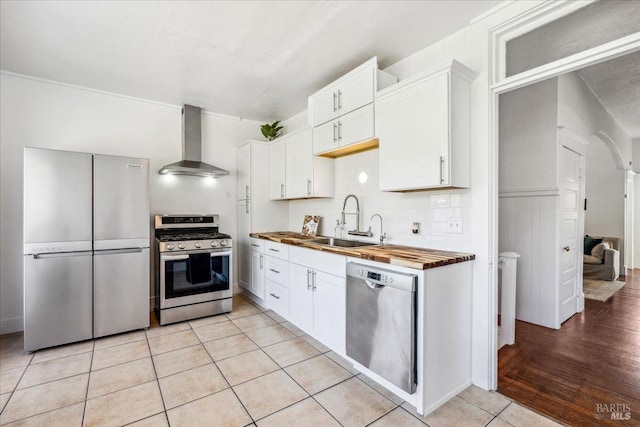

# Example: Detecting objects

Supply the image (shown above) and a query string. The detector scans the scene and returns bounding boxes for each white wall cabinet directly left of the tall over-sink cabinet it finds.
[285,129,334,199]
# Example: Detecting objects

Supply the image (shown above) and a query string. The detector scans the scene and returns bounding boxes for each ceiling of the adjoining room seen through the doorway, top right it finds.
[578,51,640,138]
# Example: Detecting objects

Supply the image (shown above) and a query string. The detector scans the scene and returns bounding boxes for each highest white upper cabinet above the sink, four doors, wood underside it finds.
[309,57,398,157]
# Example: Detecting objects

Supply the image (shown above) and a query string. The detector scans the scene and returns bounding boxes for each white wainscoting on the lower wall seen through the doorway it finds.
[499,196,559,329]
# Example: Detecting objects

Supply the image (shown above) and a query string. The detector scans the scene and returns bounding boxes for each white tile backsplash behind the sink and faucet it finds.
[289,149,471,251]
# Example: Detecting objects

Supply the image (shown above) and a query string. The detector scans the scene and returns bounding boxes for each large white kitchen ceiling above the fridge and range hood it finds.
[0,0,500,121]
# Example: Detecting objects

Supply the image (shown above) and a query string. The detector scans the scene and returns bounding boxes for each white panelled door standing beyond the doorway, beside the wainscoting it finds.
[558,146,584,323]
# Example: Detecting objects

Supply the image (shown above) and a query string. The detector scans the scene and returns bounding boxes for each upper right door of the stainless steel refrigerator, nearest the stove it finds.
[93,154,150,250]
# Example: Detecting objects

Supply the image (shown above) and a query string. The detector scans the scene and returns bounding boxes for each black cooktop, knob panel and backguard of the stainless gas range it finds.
[155,215,232,252]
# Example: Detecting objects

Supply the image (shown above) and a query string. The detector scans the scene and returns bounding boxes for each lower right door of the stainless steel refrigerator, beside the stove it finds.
[93,248,150,338]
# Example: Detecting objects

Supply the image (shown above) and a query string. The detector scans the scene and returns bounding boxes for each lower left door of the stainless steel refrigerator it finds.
[24,251,93,351]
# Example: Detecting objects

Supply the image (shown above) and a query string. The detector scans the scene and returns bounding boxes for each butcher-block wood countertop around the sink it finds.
[250,231,476,270]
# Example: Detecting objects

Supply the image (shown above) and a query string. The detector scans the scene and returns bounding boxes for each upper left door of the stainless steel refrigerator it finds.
[24,148,92,253]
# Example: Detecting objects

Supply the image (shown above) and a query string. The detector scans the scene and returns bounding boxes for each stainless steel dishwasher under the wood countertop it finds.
[347,262,417,393]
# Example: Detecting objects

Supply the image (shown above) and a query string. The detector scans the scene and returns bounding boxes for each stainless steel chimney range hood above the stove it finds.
[159,105,229,178]
